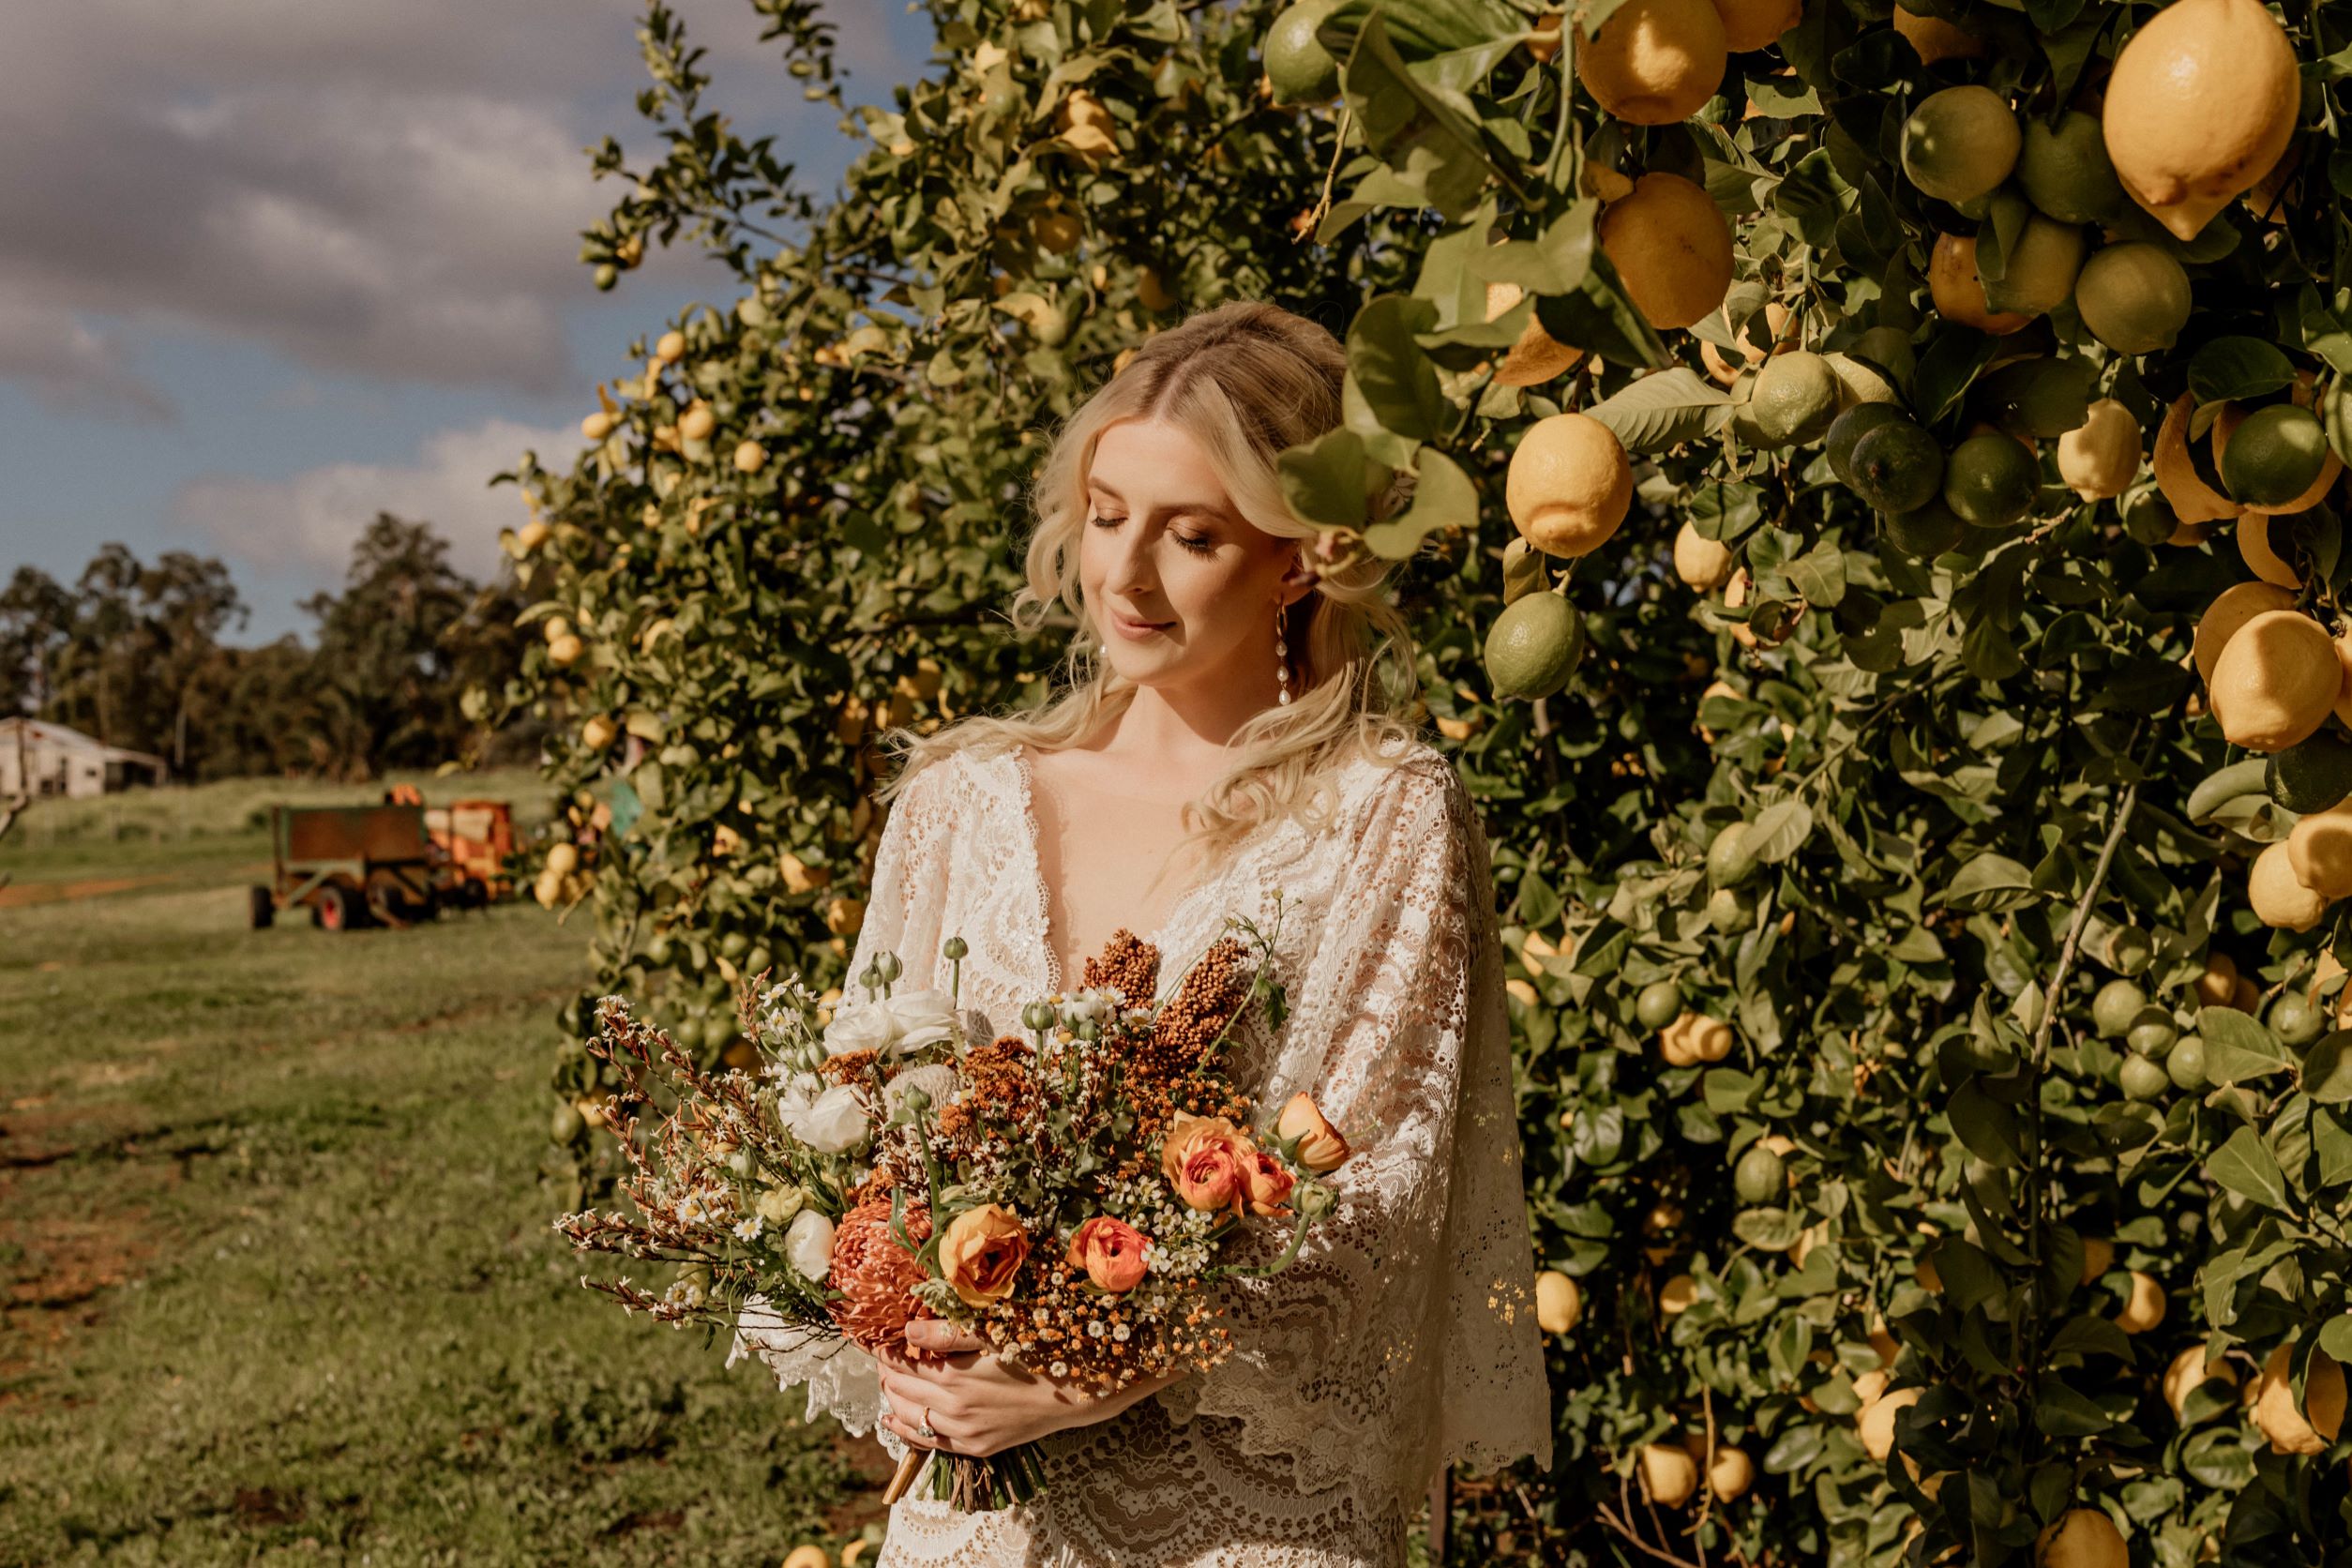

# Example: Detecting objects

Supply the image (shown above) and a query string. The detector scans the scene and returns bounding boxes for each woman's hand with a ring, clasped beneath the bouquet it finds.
[875,1319,1184,1457]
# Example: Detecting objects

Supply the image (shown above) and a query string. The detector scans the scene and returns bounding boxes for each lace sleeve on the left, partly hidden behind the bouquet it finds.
[727,760,955,1448]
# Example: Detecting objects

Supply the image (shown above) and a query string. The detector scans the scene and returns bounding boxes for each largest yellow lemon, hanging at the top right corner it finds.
[2101,0,2302,240]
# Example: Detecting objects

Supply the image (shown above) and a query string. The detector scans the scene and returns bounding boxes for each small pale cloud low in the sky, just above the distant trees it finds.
[174,418,580,580]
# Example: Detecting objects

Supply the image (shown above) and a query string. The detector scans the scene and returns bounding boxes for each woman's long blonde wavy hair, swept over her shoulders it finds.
[875,301,1421,879]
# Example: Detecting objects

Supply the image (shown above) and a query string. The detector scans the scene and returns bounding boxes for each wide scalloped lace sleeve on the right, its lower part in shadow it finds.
[1159,760,1550,1507]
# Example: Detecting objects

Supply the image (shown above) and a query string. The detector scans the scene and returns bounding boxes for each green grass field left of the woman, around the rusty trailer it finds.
[0,774,882,1568]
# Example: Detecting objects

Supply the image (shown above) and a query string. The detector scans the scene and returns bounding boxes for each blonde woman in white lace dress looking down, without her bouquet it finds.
[736,303,1552,1568]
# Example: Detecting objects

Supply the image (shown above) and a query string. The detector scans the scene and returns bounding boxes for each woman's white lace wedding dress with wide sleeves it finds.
[729,746,1552,1568]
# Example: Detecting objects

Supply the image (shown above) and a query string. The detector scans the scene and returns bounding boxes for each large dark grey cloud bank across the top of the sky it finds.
[0,0,917,414]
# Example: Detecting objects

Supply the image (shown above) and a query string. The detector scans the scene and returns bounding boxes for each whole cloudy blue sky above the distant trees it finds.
[0,0,931,641]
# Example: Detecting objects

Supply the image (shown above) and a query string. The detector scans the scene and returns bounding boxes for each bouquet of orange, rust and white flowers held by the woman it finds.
[555,917,1348,1509]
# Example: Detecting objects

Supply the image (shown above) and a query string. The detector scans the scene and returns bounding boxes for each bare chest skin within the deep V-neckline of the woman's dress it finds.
[1028,750,1207,985]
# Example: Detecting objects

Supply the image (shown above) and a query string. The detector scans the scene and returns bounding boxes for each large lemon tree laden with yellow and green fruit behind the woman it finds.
[485,0,2352,1568]
